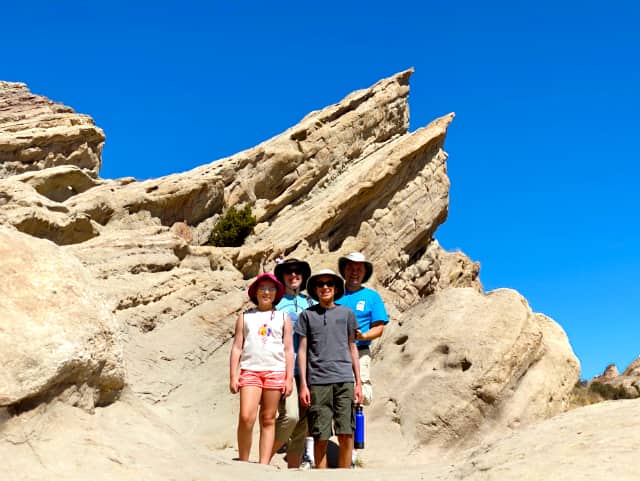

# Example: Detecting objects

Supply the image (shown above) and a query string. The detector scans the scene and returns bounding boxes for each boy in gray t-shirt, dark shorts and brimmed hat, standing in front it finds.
[295,269,362,469]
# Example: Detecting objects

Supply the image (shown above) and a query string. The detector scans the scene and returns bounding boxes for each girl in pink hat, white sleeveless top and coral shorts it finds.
[229,272,293,464]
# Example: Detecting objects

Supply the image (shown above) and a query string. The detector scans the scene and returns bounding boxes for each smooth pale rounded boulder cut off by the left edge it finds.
[0,226,124,409]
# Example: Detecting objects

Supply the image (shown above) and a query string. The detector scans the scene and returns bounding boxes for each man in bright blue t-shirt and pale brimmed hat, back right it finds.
[336,252,389,405]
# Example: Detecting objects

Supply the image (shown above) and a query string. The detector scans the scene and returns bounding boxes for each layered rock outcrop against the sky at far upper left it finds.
[0,81,105,179]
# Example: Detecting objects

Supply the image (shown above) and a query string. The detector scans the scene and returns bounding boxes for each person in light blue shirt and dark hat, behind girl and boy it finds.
[273,258,315,468]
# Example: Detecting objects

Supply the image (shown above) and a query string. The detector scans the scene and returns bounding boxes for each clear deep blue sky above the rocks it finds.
[0,0,640,378]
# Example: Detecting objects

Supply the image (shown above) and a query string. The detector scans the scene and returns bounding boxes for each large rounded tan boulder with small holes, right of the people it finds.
[369,288,579,462]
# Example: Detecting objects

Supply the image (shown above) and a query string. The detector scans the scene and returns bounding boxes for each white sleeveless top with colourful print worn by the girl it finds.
[240,308,286,371]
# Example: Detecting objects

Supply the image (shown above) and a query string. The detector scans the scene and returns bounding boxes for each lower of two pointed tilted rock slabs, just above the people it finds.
[238,116,453,268]
